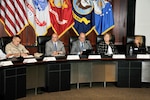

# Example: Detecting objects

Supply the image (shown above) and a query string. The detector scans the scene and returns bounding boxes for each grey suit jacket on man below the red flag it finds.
[45,40,66,56]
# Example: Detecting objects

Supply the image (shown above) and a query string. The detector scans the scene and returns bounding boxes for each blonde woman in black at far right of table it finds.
[127,36,146,54]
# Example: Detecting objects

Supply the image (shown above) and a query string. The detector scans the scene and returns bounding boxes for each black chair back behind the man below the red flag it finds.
[37,36,51,53]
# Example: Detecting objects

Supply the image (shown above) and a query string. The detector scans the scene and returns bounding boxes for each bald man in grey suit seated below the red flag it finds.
[45,33,66,56]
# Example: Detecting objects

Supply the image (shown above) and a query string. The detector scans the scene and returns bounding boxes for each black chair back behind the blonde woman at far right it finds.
[126,35,146,46]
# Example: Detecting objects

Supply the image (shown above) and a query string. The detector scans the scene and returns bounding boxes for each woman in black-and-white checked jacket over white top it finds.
[97,33,118,55]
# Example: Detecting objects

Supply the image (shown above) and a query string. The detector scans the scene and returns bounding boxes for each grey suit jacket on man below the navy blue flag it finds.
[70,40,92,54]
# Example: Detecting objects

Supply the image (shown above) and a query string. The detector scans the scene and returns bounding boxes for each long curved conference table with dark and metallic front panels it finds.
[0,55,150,100]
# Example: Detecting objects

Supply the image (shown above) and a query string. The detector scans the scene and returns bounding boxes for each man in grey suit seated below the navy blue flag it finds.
[71,33,92,55]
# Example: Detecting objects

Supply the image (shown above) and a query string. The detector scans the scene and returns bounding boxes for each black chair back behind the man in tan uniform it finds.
[0,37,12,52]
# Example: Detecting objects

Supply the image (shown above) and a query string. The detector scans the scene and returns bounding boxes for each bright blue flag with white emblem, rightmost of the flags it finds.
[93,0,114,35]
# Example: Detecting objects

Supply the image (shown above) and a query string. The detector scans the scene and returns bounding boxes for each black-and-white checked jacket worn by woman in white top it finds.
[97,41,118,55]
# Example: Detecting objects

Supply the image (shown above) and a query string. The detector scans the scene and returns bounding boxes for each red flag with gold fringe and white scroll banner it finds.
[49,0,74,37]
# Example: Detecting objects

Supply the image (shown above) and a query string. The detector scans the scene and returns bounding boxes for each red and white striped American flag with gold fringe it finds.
[0,0,28,36]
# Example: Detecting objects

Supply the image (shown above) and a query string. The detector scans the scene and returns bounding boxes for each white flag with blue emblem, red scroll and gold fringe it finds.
[25,0,51,36]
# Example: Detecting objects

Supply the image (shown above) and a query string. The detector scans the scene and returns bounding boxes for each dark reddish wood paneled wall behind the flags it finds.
[0,0,128,53]
